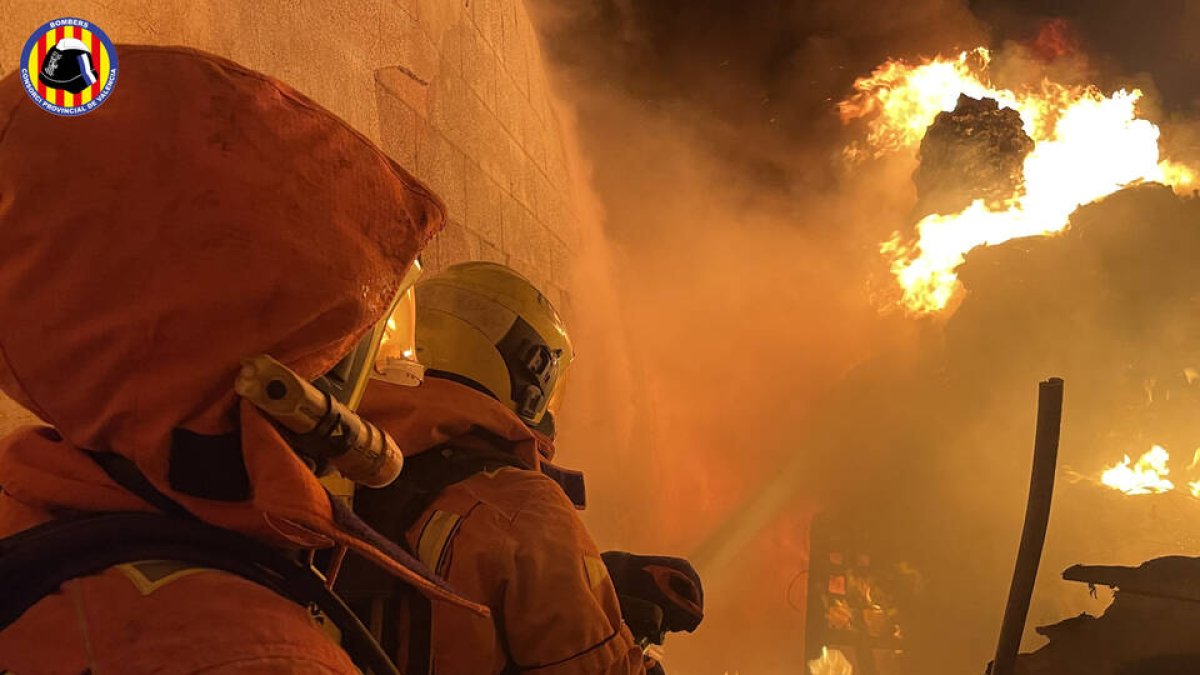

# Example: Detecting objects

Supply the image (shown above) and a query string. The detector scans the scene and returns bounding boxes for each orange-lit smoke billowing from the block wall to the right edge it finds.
[530,0,1200,675]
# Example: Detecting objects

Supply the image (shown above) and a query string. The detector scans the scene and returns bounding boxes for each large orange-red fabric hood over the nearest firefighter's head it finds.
[0,46,443,468]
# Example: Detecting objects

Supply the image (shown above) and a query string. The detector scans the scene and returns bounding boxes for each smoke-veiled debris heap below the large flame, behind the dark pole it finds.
[810,120,1200,674]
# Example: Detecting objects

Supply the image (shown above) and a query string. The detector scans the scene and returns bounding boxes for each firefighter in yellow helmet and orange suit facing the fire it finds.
[338,262,702,675]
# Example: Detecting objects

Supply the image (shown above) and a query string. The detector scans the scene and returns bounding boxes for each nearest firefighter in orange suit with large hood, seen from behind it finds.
[0,46,486,675]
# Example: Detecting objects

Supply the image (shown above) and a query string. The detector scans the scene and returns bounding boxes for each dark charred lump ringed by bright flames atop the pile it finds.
[913,94,1033,217]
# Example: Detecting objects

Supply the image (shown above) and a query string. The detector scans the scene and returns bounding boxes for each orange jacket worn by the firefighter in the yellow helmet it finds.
[360,377,644,675]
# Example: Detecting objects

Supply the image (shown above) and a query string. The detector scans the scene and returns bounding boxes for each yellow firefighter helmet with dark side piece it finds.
[416,262,575,427]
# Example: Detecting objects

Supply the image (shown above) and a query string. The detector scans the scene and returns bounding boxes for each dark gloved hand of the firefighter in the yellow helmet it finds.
[600,551,704,647]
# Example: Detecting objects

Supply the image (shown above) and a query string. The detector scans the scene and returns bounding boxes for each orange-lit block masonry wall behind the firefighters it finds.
[0,0,580,434]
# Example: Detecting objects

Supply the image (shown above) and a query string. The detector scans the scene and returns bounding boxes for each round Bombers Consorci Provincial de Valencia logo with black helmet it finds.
[20,17,116,117]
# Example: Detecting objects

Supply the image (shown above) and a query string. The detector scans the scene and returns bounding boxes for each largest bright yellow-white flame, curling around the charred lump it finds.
[838,48,1196,313]
